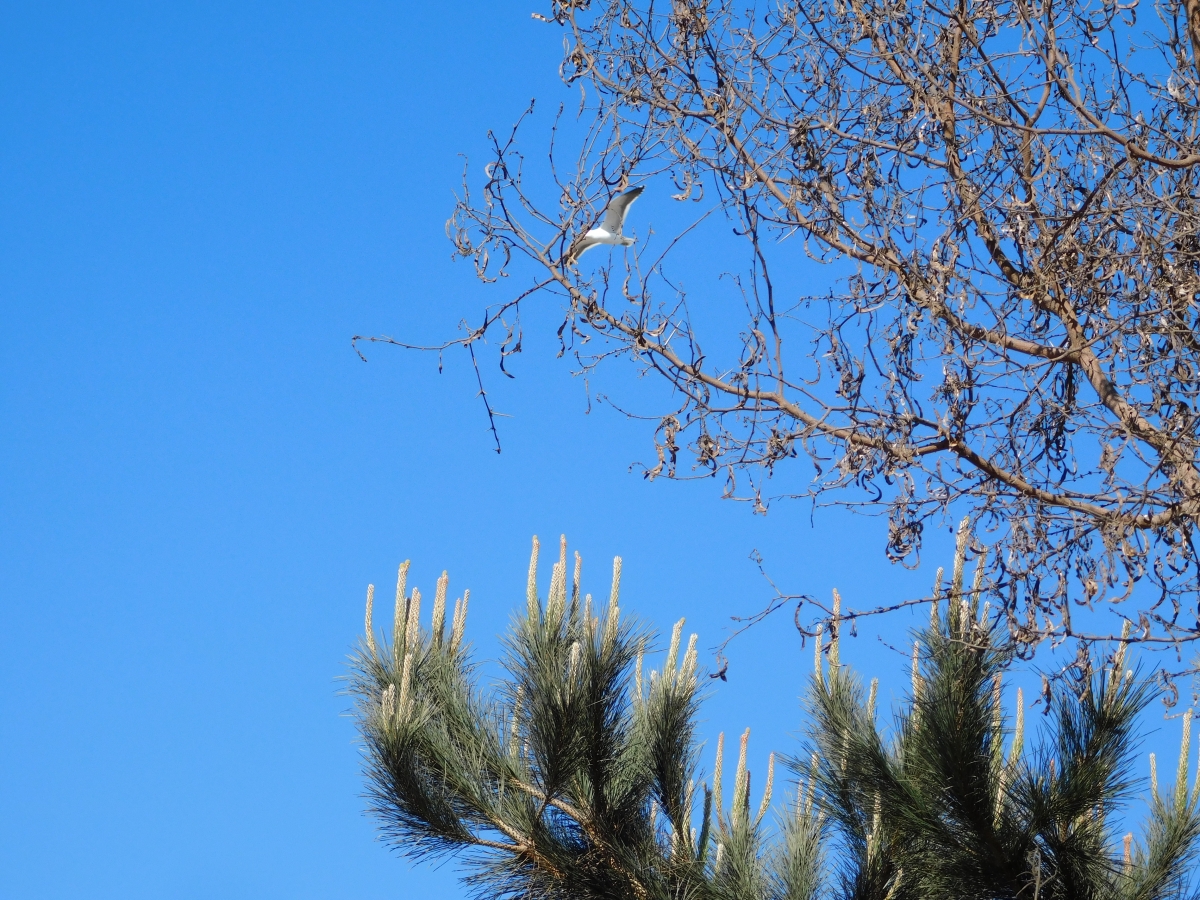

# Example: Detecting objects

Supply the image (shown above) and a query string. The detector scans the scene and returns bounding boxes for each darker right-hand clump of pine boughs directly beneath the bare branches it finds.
[806,529,1200,900]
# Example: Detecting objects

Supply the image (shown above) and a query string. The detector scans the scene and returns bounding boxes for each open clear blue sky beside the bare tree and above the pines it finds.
[0,2,1176,900]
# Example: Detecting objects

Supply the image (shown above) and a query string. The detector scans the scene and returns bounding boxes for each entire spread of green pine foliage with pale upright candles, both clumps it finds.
[350,532,1200,900]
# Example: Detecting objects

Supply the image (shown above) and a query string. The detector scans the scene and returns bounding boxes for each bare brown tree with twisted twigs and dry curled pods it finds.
[360,0,1200,650]
